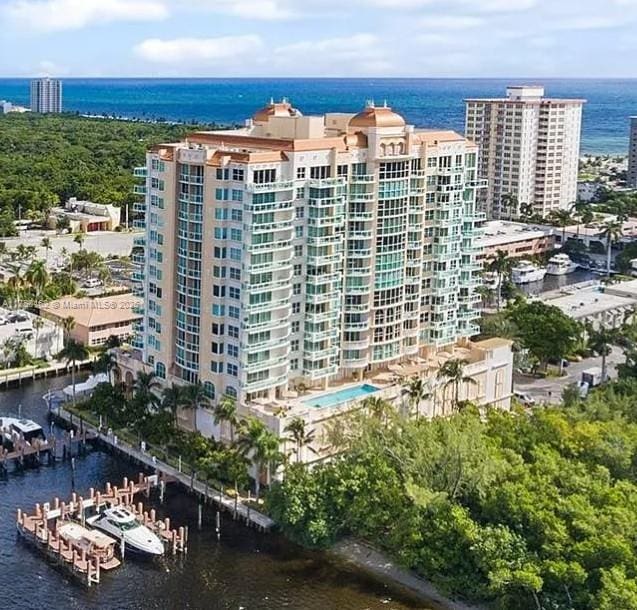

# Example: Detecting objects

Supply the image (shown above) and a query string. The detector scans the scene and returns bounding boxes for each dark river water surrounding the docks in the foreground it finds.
[0,378,433,610]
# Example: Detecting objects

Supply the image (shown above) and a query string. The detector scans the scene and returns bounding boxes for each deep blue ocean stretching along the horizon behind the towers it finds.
[0,78,637,154]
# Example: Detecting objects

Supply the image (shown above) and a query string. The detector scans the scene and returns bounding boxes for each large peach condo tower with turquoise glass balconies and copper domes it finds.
[136,101,484,403]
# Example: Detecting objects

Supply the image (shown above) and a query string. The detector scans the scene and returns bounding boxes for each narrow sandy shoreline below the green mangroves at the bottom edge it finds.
[330,538,485,610]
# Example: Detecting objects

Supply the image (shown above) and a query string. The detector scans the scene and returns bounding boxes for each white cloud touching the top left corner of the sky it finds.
[2,0,168,32]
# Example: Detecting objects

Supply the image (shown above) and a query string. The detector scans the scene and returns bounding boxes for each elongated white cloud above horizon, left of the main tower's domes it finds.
[135,35,263,64]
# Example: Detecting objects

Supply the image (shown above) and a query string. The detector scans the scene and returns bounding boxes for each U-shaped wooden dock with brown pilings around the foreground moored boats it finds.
[16,473,188,587]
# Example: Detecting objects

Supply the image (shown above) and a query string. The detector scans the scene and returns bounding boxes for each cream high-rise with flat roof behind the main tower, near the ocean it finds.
[466,87,585,219]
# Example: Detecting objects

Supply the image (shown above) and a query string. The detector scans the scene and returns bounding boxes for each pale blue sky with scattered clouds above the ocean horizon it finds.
[0,0,637,77]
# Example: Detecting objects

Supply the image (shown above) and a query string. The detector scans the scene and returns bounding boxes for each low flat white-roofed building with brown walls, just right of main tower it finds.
[478,220,555,260]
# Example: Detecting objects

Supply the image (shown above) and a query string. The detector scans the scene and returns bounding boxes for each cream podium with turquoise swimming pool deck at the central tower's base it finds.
[113,339,513,462]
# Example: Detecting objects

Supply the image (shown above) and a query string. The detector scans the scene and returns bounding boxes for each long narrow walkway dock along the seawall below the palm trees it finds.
[50,404,275,532]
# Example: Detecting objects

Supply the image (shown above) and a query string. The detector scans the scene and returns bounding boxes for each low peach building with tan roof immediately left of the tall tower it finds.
[40,294,143,347]
